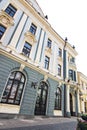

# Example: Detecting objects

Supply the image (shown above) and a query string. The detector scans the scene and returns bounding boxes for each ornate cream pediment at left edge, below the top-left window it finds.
[0,10,14,27]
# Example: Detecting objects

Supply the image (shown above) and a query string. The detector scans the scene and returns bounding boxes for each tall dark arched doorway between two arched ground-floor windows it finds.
[35,81,48,115]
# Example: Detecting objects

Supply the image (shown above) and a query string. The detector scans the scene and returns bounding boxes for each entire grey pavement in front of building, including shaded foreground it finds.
[0,116,77,130]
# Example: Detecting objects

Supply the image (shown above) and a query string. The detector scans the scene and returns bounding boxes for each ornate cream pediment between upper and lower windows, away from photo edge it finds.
[25,31,36,45]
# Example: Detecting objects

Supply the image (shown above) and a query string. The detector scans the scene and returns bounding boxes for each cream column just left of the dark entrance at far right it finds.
[66,85,70,117]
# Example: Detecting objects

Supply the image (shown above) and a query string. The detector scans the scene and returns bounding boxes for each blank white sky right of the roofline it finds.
[37,0,87,76]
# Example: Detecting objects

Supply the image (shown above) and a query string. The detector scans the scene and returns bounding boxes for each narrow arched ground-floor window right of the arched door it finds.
[55,87,61,110]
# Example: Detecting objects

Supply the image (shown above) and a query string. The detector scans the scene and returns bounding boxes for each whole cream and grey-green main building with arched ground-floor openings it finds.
[0,0,85,116]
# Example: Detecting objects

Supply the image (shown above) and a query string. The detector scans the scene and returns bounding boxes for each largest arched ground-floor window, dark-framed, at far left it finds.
[1,71,26,105]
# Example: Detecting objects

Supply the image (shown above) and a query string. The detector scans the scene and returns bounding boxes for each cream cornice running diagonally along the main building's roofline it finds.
[19,0,78,55]
